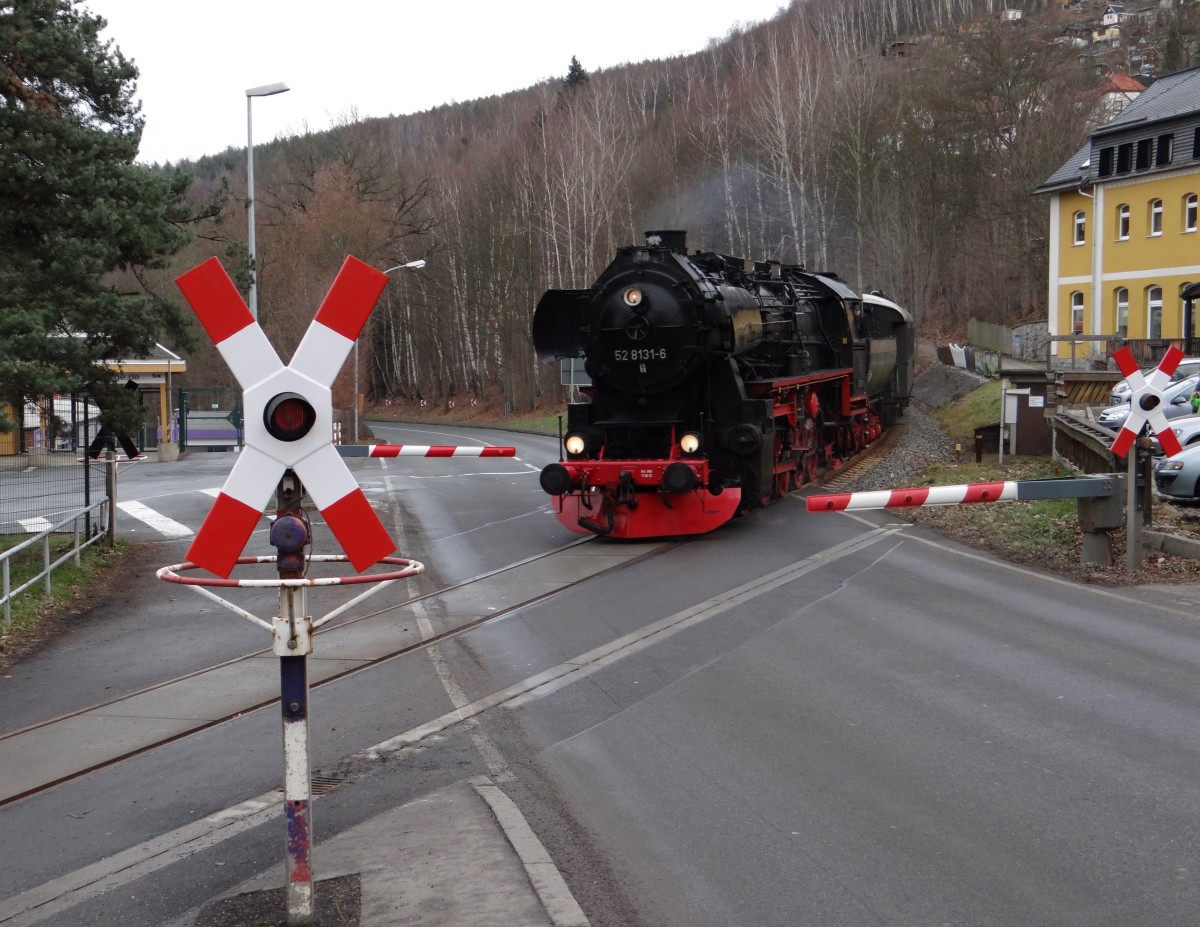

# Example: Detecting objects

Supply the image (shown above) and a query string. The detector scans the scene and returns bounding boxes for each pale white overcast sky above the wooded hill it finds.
[84,0,786,163]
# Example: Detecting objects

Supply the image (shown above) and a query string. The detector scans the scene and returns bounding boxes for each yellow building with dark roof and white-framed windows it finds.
[1036,68,1200,357]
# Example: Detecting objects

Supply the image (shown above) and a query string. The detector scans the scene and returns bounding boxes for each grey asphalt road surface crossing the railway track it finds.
[0,429,1200,927]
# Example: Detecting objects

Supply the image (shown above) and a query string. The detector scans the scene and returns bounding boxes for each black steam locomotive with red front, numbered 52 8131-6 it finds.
[533,231,914,538]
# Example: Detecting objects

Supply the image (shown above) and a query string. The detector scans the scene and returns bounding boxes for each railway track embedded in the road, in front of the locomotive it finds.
[0,538,684,807]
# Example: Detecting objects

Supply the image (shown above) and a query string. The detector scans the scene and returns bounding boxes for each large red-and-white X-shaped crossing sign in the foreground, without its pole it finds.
[175,257,396,578]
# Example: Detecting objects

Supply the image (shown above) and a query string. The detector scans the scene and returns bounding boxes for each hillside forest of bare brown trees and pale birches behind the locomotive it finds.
[163,0,1193,409]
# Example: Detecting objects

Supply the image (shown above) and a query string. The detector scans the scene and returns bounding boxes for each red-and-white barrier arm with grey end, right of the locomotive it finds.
[805,477,1116,512]
